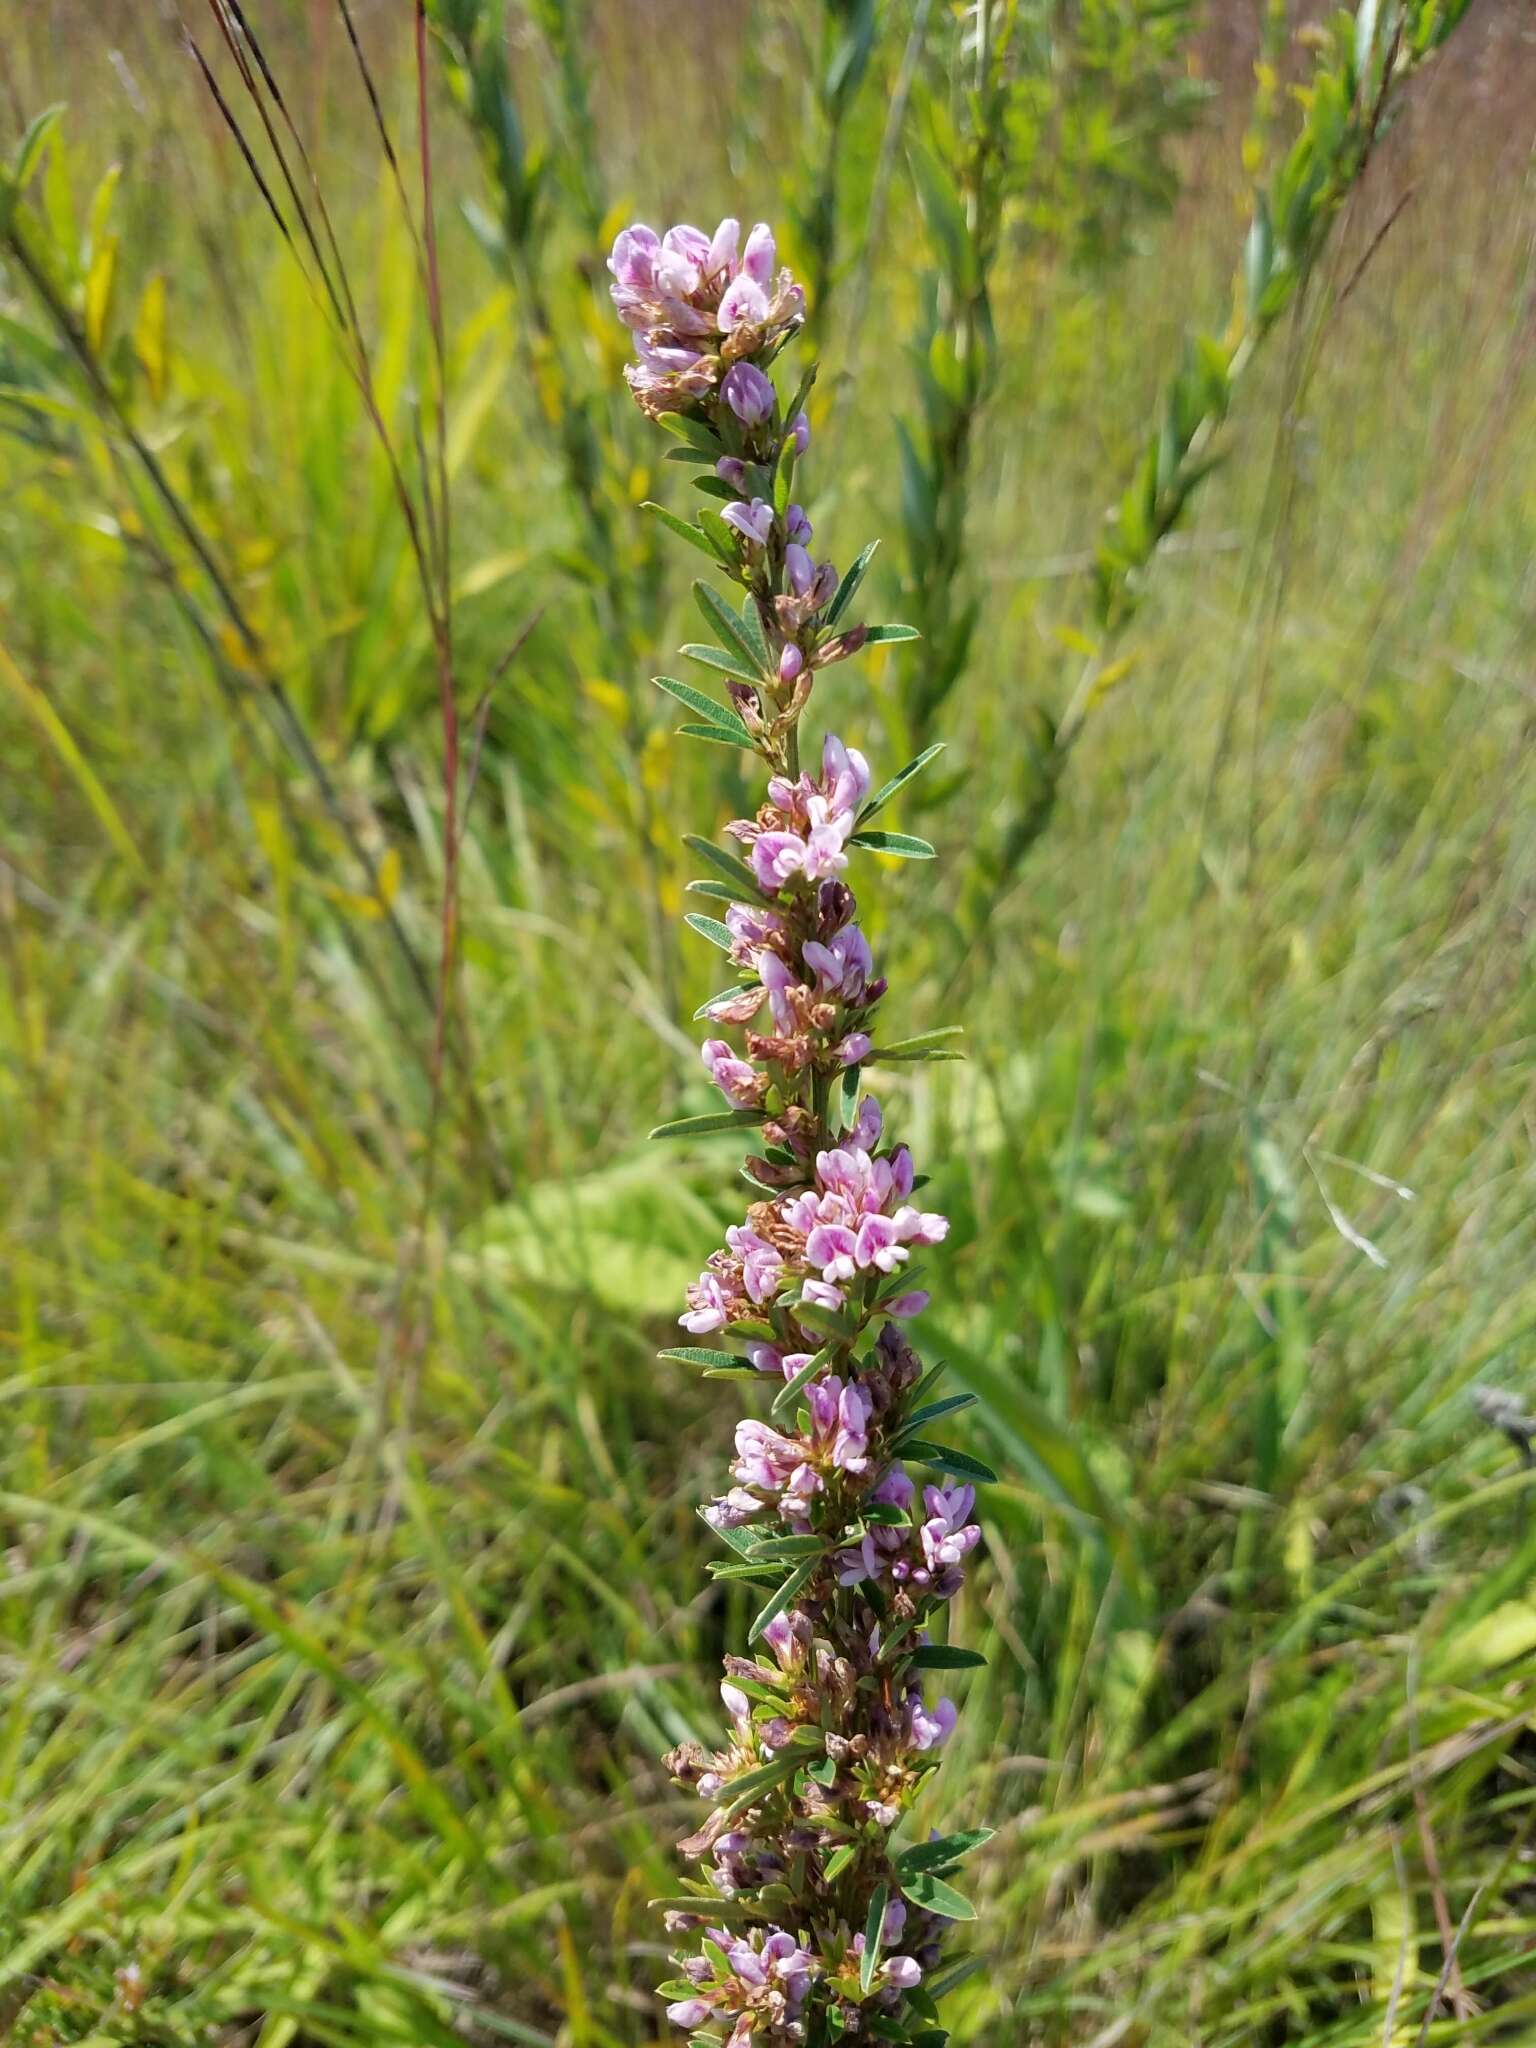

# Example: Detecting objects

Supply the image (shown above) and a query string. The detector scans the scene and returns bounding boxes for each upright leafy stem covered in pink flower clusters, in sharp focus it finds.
[608,221,993,2048]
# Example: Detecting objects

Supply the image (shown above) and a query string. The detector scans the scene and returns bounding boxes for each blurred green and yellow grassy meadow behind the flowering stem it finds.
[0,0,1536,2048]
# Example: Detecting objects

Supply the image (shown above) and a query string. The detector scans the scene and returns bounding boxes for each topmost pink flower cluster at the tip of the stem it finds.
[608,219,805,414]
